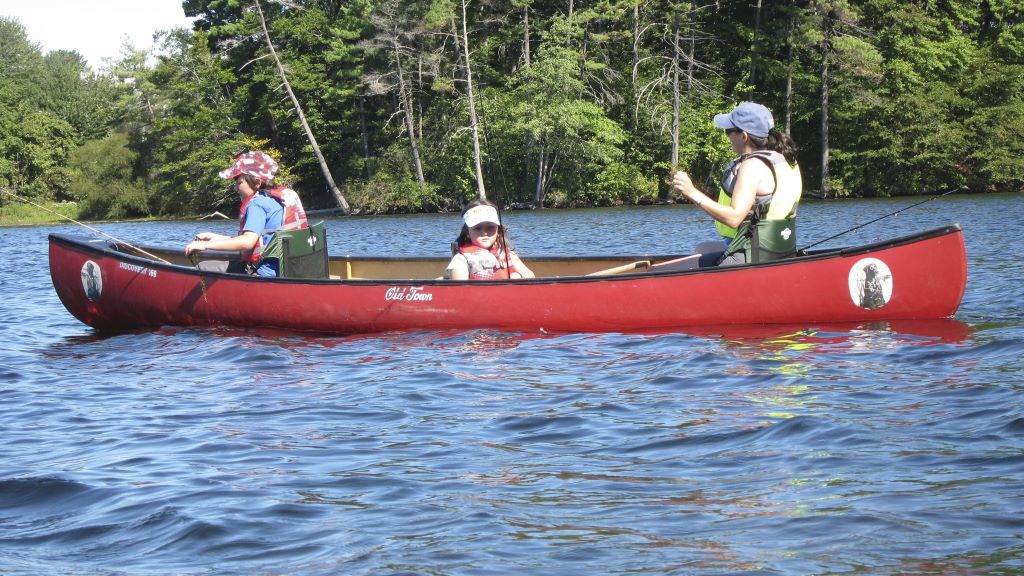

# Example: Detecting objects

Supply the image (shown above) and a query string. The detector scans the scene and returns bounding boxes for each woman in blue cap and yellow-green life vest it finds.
[673,102,803,266]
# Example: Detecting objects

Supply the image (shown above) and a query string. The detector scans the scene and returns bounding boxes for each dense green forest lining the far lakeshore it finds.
[0,0,1024,217]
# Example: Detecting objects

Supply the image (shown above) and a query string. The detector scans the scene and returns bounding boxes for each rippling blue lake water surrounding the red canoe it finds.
[0,196,1024,575]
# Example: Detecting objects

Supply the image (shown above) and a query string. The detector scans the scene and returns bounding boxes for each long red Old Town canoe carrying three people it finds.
[49,224,967,334]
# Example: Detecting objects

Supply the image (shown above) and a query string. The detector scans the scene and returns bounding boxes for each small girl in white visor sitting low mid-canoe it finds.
[445,200,534,280]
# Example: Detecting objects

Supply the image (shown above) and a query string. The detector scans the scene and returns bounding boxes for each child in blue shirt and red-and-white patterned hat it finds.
[185,147,309,276]
